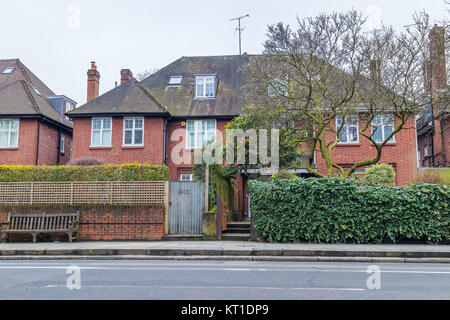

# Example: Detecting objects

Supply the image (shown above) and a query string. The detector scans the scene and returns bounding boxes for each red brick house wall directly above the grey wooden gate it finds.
[167,119,230,181]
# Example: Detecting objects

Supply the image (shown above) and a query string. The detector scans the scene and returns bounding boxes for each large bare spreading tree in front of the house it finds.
[244,11,430,178]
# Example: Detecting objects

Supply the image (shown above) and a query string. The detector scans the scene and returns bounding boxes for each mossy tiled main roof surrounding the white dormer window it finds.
[142,54,258,117]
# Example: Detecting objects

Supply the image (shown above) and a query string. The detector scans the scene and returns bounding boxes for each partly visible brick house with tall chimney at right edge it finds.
[417,25,450,167]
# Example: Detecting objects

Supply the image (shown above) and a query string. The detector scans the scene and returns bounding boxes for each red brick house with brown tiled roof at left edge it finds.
[0,59,76,165]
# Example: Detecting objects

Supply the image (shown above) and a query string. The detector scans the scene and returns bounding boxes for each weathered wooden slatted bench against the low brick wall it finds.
[0,211,80,242]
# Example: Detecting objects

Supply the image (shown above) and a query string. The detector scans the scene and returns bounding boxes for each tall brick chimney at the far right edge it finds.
[429,24,447,97]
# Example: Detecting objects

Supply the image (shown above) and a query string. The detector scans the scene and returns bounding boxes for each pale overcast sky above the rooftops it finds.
[0,0,446,106]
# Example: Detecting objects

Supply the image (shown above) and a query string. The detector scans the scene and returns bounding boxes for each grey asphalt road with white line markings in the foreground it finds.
[0,260,450,300]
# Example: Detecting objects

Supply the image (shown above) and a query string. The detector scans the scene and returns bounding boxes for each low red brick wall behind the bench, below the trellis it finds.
[0,206,164,241]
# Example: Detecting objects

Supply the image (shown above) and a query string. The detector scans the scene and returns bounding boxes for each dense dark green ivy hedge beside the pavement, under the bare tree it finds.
[249,178,450,243]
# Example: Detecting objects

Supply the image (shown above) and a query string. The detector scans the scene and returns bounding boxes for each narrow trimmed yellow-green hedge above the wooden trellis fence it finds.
[0,164,169,182]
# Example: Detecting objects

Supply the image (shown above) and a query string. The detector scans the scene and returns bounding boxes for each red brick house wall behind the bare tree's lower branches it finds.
[316,117,417,185]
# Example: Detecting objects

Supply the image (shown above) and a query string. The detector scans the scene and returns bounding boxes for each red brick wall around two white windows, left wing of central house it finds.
[72,117,164,165]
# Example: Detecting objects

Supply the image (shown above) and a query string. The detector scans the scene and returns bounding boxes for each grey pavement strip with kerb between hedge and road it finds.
[0,241,450,263]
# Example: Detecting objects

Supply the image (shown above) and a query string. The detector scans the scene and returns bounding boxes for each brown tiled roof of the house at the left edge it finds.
[0,59,72,128]
